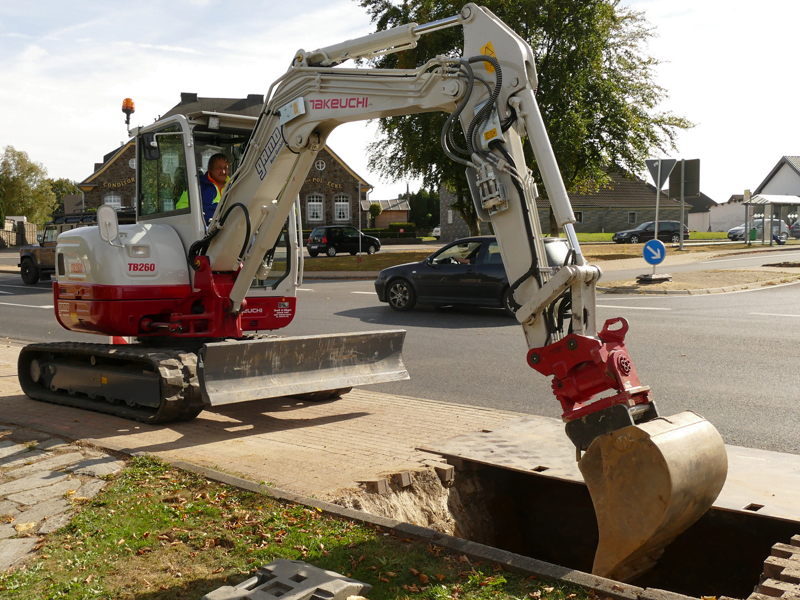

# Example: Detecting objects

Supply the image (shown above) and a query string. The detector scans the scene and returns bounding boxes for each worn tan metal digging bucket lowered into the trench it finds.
[578,411,728,581]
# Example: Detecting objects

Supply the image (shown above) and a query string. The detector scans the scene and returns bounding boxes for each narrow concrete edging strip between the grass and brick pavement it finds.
[80,439,691,600]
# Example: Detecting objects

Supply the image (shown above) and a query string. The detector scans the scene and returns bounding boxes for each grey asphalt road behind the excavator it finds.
[0,274,800,454]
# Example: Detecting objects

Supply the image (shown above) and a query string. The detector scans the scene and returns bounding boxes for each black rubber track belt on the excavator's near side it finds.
[17,342,205,425]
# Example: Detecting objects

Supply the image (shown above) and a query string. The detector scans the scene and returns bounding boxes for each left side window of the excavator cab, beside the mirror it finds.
[137,123,189,216]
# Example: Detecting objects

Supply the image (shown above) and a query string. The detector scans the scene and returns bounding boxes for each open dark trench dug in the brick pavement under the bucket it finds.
[334,463,800,598]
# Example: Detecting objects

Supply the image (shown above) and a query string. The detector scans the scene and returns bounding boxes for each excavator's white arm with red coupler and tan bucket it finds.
[184,4,727,580]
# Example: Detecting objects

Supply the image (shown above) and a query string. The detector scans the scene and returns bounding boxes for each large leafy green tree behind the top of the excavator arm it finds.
[359,0,692,234]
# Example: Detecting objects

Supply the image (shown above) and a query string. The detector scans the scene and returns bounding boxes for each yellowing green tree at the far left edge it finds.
[0,146,56,225]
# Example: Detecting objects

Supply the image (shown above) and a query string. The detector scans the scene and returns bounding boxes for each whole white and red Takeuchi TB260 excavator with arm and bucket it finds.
[19,4,727,580]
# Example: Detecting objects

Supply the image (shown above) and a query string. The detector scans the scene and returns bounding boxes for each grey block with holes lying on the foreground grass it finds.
[202,559,372,600]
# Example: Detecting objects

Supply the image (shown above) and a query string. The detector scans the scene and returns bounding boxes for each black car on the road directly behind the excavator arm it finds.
[375,236,569,315]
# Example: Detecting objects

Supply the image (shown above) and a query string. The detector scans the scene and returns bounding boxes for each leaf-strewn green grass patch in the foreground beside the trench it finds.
[0,457,593,600]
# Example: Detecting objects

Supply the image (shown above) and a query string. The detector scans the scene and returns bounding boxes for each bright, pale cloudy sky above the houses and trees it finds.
[0,0,800,202]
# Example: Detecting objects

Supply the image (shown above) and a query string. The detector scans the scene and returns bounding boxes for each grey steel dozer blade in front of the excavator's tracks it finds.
[197,330,408,406]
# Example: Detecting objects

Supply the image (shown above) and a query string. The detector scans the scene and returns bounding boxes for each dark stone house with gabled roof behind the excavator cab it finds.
[78,93,398,228]
